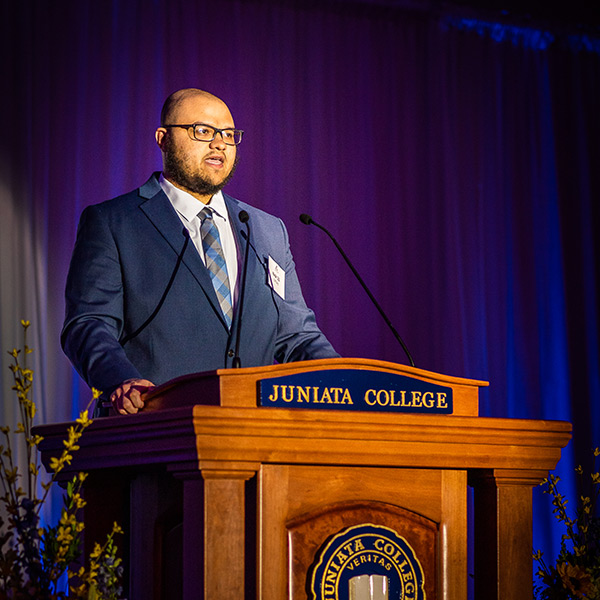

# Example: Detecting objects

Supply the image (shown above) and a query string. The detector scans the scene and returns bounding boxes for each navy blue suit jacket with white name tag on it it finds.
[61,173,338,393]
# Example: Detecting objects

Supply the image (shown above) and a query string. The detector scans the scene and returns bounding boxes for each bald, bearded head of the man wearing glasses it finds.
[155,88,237,203]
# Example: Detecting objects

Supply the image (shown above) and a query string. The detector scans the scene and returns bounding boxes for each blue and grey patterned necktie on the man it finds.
[198,207,233,327]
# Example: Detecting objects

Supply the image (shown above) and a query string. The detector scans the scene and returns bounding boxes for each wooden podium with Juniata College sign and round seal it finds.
[36,359,571,600]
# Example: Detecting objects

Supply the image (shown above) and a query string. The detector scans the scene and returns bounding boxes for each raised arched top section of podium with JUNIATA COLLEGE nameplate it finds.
[144,358,488,416]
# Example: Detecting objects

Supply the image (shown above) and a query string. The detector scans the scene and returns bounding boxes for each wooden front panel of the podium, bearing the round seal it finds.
[258,465,467,600]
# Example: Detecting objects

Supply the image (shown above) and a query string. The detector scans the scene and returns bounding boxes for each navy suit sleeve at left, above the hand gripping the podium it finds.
[61,206,141,393]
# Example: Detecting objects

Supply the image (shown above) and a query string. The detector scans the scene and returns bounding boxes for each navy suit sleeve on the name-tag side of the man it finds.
[275,221,339,362]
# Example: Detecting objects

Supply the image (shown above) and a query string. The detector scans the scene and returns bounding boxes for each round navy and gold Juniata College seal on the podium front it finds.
[308,523,425,600]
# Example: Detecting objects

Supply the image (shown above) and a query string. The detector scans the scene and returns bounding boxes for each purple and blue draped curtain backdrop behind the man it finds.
[0,0,600,592]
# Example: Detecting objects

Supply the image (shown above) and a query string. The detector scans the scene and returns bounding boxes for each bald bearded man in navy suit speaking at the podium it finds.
[61,88,338,416]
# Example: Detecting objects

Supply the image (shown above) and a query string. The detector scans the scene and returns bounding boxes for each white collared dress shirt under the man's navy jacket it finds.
[159,173,238,305]
